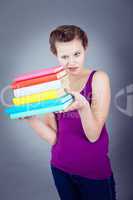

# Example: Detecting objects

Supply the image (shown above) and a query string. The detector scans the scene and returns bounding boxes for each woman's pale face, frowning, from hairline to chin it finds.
[55,39,85,75]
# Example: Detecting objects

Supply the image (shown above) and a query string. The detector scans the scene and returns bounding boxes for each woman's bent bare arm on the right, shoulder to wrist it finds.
[79,70,111,142]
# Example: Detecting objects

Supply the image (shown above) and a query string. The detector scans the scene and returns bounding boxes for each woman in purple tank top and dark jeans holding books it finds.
[23,25,116,200]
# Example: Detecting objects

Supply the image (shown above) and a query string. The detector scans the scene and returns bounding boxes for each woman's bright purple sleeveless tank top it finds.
[51,70,112,179]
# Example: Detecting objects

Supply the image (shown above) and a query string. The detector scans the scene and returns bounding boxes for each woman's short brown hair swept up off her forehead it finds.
[49,25,88,55]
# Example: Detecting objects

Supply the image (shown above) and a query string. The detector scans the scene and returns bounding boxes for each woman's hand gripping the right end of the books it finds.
[60,88,88,112]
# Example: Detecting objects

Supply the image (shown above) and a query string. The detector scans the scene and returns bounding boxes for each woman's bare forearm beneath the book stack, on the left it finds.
[25,113,57,145]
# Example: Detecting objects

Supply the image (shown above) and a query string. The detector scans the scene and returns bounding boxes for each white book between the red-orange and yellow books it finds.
[13,75,69,98]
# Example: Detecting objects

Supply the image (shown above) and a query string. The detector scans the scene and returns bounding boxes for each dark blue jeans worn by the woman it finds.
[51,165,116,200]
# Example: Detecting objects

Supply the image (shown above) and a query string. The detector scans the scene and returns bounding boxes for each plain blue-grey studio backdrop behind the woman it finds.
[0,0,133,200]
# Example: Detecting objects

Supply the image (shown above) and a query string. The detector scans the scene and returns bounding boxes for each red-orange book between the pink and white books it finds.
[11,70,67,89]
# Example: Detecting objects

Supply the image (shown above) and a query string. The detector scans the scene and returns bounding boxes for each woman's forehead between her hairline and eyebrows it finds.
[55,39,83,54]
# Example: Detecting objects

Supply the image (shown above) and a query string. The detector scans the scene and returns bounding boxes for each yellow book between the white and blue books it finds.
[12,88,66,105]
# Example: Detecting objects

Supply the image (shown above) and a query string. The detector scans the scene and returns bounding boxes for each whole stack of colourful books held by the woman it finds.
[5,66,74,119]
